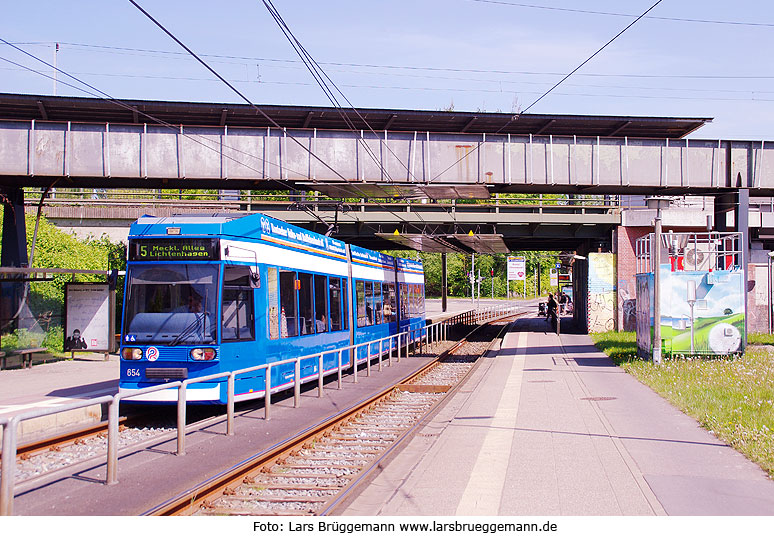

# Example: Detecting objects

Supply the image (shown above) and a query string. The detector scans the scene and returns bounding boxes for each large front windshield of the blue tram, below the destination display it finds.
[123,264,218,345]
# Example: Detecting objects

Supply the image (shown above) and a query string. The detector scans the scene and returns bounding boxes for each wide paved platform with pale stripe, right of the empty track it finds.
[341,318,774,516]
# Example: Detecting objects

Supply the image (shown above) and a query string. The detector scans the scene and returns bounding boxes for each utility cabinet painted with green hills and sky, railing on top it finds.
[636,233,747,358]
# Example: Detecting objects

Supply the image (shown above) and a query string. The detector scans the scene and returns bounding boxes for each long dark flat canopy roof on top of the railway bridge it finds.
[0,93,712,138]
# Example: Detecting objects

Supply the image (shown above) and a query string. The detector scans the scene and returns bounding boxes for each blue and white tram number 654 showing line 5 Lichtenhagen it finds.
[120,214,424,404]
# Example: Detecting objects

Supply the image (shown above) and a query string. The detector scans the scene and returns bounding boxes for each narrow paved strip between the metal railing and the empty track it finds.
[14,350,442,516]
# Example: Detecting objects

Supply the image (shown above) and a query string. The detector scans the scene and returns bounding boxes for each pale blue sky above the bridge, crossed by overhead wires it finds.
[0,0,774,140]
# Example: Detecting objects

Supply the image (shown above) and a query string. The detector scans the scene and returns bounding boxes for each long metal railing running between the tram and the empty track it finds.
[0,303,518,516]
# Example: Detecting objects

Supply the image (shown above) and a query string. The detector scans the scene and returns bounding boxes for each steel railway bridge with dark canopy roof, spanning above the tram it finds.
[0,94,774,332]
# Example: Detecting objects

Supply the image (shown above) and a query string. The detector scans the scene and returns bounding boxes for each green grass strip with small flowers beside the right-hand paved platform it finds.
[591,332,774,478]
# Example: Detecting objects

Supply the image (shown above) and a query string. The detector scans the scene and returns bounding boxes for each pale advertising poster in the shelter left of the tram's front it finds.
[63,282,110,352]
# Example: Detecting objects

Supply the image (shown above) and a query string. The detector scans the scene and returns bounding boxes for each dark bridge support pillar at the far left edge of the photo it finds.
[0,186,27,331]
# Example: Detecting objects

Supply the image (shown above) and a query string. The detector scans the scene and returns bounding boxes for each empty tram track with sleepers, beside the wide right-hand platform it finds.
[144,312,525,516]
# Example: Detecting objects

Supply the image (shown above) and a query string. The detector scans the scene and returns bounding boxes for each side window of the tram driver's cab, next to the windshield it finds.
[221,265,255,341]
